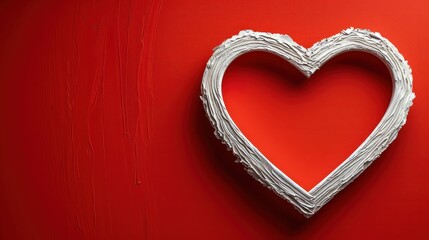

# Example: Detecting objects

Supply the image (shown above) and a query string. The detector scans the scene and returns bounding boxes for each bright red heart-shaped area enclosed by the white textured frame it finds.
[222,52,392,191]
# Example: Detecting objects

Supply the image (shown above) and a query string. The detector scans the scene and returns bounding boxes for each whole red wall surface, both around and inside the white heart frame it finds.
[0,0,429,239]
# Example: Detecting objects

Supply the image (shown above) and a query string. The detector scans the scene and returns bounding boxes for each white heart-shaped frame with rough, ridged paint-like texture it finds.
[201,28,415,217]
